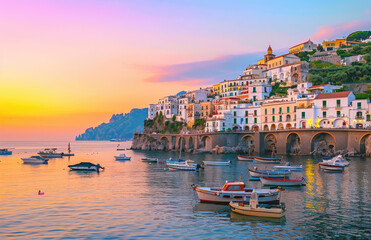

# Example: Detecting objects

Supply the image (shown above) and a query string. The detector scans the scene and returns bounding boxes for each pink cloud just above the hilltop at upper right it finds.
[310,21,371,42]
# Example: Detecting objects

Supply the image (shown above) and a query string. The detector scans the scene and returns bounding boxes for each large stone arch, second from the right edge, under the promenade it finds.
[310,132,336,156]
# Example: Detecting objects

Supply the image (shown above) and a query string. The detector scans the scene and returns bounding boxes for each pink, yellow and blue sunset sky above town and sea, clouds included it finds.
[0,0,371,141]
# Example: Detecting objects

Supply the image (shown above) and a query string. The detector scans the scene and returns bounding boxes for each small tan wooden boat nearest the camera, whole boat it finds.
[229,191,286,218]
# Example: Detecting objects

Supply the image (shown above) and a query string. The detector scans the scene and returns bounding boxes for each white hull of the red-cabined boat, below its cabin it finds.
[195,188,280,204]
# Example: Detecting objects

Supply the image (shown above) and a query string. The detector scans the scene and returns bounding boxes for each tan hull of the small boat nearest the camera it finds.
[229,202,285,218]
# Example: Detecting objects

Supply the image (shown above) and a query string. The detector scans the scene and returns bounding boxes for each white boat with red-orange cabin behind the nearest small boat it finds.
[192,181,280,204]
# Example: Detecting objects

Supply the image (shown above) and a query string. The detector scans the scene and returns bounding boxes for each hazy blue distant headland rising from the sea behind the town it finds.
[76,108,148,140]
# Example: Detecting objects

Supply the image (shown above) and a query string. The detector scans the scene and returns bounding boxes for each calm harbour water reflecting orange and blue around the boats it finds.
[0,142,371,239]
